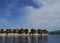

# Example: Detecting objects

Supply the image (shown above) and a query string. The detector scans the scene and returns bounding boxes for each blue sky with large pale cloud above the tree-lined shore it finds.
[0,0,60,31]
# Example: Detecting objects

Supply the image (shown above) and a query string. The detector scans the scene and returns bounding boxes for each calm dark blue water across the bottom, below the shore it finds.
[0,35,60,43]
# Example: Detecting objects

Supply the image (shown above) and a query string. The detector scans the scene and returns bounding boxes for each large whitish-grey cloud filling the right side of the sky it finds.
[25,0,60,28]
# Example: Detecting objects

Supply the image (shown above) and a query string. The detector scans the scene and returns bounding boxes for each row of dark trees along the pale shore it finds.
[0,28,48,34]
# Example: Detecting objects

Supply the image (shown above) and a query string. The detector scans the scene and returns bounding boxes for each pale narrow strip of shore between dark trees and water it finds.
[0,33,48,36]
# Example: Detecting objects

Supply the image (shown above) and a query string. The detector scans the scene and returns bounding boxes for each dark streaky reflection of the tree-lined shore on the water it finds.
[0,36,48,43]
